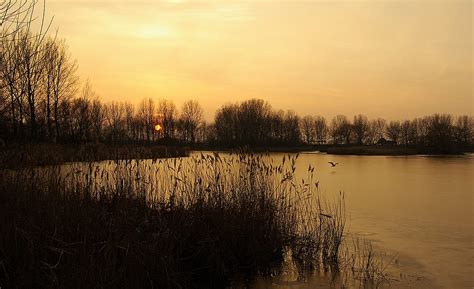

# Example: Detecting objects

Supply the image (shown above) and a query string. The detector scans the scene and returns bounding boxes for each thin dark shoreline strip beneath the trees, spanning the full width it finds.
[0,143,472,169]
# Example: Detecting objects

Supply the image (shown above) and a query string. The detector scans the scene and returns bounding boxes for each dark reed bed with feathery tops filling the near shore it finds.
[0,154,384,288]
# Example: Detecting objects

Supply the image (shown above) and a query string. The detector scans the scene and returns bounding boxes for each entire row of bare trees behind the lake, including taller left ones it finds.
[0,16,474,152]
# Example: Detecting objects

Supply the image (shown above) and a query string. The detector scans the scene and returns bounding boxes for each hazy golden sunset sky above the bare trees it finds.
[42,0,474,120]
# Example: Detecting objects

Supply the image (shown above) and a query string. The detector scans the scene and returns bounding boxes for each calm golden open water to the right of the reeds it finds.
[250,153,474,289]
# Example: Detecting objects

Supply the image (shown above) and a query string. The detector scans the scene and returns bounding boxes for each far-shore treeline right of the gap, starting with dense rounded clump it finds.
[208,99,474,150]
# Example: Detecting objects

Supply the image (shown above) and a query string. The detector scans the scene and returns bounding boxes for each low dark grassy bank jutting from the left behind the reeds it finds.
[0,143,188,169]
